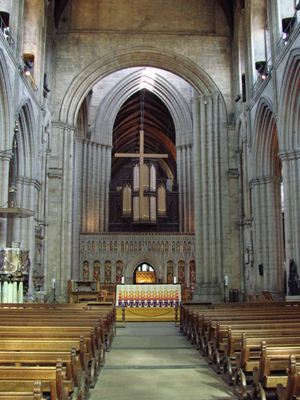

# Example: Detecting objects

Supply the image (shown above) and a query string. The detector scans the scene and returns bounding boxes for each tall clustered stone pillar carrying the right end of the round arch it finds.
[193,94,222,301]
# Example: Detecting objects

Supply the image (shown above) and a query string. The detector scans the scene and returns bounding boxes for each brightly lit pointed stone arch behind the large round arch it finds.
[94,69,193,148]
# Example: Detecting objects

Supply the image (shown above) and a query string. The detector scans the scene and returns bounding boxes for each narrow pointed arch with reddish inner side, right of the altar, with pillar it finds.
[249,98,284,297]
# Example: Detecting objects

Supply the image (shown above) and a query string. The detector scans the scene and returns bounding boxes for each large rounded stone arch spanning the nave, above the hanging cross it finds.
[59,48,227,125]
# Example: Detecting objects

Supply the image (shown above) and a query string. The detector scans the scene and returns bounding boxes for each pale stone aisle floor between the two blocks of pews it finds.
[90,322,236,400]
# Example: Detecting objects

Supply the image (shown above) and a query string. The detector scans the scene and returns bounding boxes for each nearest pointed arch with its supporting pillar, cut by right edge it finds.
[279,48,300,274]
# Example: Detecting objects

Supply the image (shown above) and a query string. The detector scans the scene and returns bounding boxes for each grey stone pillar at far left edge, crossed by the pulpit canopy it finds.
[0,152,13,247]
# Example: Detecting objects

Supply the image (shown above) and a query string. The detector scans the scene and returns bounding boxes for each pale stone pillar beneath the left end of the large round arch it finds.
[46,122,75,301]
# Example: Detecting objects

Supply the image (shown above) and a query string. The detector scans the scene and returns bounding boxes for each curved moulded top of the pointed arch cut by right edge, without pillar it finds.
[278,48,300,151]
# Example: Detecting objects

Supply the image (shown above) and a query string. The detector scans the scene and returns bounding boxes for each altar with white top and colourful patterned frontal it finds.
[116,285,181,308]
